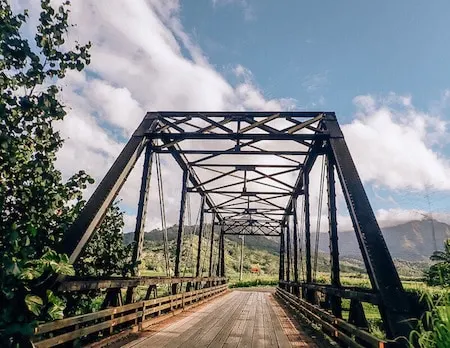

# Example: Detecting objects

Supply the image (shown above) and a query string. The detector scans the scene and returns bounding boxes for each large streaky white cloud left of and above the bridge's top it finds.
[34,0,288,230]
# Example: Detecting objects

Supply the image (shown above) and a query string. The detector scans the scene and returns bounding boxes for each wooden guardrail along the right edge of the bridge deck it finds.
[276,287,393,348]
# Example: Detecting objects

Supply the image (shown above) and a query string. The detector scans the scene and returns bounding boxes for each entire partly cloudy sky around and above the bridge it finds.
[13,0,450,231]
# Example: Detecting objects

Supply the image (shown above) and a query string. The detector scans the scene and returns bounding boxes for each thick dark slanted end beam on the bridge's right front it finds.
[323,115,412,338]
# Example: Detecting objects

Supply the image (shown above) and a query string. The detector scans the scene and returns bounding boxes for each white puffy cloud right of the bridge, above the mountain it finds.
[342,94,450,190]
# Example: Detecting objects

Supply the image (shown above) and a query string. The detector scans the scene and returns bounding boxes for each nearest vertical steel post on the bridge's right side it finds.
[326,150,342,318]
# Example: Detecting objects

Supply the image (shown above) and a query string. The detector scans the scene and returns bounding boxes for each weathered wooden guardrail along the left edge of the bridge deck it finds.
[33,284,228,348]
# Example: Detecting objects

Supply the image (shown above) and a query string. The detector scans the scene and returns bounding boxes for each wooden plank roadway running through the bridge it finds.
[125,291,316,348]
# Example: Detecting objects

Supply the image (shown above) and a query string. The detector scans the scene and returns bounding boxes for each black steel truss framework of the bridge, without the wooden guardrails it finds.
[63,112,410,337]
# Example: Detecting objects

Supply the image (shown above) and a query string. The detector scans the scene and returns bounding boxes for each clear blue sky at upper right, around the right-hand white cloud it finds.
[181,0,450,216]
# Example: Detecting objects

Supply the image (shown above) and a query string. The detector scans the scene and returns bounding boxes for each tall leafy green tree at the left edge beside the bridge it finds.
[0,0,93,346]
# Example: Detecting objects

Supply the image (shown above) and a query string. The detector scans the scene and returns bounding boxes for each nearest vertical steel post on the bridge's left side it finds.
[132,144,153,275]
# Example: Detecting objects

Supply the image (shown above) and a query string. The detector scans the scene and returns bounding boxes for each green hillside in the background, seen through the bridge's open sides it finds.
[124,225,429,278]
